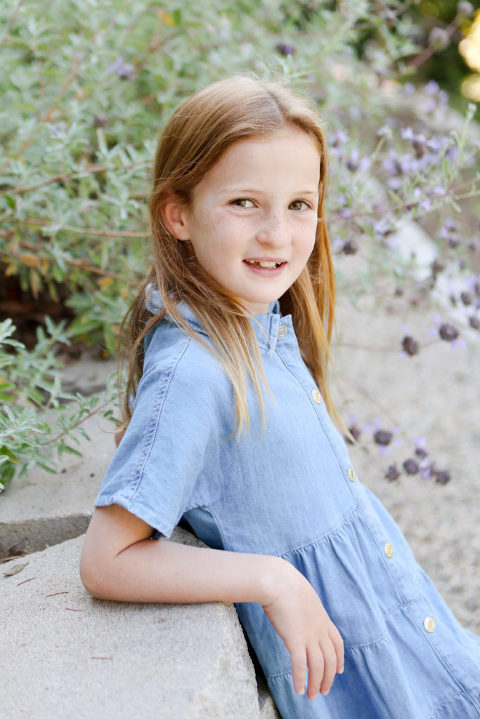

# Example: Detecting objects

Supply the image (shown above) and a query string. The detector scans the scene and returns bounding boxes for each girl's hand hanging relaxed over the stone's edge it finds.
[262,560,343,699]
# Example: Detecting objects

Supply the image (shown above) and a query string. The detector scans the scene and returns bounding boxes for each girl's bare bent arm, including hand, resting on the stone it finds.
[80,504,343,699]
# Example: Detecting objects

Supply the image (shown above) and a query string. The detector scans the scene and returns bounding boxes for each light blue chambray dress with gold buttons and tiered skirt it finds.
[95,291,480,719]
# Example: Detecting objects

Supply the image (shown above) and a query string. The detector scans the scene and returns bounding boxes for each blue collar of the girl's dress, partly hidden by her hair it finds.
[146,284,293,355]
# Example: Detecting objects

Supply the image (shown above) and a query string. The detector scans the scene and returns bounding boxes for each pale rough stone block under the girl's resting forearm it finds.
[0,529,264,719]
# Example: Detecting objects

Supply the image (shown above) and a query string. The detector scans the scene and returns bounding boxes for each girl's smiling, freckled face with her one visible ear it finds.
[166,125,320,315]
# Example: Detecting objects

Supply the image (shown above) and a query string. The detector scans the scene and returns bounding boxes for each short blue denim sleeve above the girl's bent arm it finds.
[95,333,224,537]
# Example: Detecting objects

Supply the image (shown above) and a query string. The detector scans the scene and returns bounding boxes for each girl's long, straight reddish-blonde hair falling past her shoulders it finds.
[122,76,344,431]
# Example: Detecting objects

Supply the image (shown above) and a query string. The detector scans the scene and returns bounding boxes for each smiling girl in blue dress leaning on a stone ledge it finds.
[81,77,480,719]
